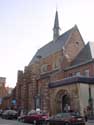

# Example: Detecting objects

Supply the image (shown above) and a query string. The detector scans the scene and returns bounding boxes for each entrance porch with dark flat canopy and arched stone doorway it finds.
[48,76,94,115]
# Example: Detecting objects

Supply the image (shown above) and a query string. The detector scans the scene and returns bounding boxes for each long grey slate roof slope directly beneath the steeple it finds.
[29,25,78,65]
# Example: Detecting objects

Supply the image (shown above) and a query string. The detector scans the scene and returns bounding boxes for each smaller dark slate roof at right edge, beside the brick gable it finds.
[71,42,94,66]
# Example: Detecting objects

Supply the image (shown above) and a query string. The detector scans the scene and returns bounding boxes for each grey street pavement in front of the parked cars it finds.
[0,118,94,125]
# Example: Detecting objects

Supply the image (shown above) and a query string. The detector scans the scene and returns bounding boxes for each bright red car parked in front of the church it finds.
[18,112,48,125]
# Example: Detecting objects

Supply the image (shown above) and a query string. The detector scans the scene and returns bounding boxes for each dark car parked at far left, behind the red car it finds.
[2,110,18,119]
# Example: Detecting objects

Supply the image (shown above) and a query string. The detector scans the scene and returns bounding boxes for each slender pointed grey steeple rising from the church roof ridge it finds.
[53,10,60,41]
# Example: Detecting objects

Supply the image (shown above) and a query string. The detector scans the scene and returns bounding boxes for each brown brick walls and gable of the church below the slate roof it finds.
[16,26,88,113]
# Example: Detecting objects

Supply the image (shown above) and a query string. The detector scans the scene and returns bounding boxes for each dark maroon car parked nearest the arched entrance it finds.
[47,112,85,125]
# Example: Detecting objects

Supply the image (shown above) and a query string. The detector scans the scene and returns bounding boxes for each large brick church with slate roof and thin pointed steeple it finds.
[16,11,94,114]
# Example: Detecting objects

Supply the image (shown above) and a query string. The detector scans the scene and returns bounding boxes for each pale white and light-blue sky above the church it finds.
[0,0,94,87]
